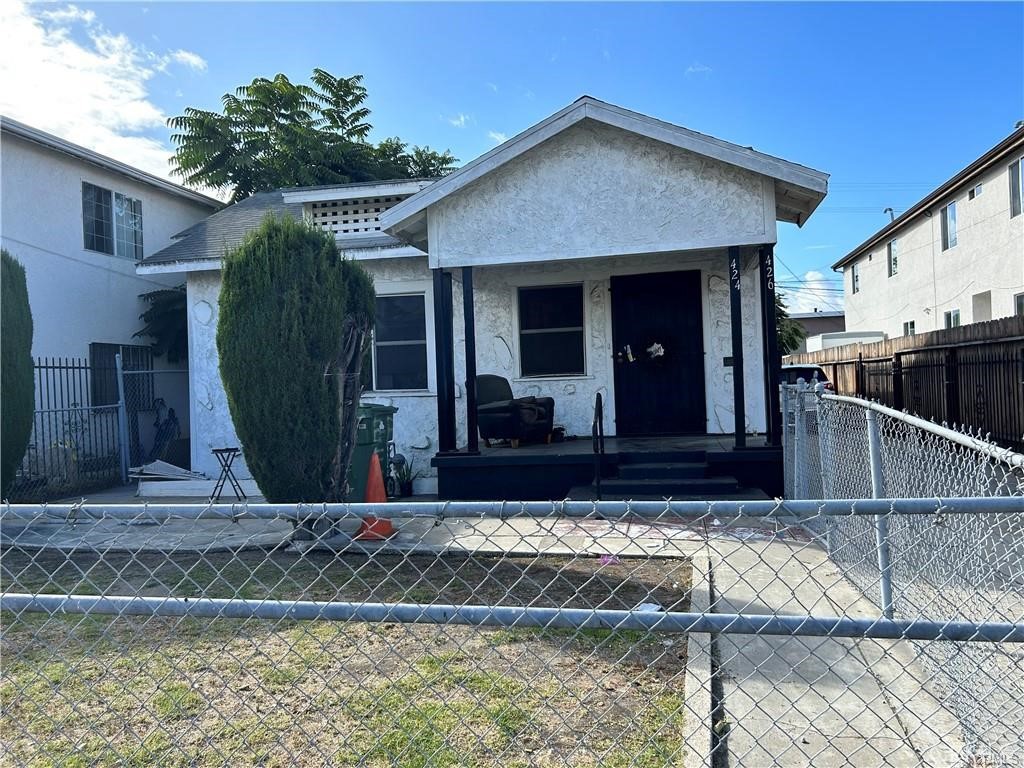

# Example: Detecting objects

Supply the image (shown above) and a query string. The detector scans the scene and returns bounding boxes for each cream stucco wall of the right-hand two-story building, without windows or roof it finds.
[843,156,1024,338]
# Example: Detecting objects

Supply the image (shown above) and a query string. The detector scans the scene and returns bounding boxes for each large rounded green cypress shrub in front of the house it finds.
[217,216,374,502]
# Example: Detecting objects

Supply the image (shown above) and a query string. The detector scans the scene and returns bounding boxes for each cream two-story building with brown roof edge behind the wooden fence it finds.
[833,127,1024,338]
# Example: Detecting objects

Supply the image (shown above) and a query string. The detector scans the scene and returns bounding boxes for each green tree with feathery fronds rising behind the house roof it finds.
[168,69,458,203]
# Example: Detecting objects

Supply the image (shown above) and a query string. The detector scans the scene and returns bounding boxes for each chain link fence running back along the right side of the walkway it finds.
[784,385,1024,765]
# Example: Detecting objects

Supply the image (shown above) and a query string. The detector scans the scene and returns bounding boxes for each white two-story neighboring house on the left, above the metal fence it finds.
[0,118,221,357]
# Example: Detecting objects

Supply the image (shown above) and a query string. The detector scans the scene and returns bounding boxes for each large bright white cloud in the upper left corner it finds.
[0,0,206,180]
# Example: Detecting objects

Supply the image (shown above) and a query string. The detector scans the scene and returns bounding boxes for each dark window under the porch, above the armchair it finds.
[519,284,587,377]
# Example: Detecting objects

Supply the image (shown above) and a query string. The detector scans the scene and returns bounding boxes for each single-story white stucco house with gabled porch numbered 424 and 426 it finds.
[138,96,827,498]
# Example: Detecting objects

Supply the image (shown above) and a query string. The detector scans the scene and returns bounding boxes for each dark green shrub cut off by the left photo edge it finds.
[0,250,36,497]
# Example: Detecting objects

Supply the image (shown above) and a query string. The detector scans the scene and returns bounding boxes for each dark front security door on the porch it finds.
[611,271,707,436]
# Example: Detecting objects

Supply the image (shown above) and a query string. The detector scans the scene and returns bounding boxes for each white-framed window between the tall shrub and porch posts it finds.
[373,294,428,390]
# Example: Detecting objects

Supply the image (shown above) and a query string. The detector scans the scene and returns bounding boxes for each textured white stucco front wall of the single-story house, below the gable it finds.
[188,251,765,490]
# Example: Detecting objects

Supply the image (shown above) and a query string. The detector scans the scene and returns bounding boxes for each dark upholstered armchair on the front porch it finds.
[476,374,555,447]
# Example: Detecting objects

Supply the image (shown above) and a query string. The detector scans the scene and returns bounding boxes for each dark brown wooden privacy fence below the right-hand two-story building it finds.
[786,316,1024,449]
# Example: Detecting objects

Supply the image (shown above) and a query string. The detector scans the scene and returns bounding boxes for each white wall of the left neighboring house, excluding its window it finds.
[0,134,212,357]
